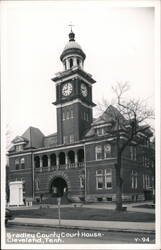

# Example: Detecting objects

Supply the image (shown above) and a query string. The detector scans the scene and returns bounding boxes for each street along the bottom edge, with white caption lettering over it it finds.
[6,224,155,244]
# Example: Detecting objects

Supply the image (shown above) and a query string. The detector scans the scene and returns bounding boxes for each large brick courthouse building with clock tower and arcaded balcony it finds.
[7,30,154,205]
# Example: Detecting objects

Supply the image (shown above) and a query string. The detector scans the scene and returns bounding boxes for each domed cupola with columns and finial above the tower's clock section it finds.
[60,30,86,70]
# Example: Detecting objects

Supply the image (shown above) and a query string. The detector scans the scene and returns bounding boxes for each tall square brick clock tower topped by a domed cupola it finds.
[52,29,95,145]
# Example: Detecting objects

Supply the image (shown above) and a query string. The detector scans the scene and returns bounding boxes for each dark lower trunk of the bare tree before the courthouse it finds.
[115,156,122,211]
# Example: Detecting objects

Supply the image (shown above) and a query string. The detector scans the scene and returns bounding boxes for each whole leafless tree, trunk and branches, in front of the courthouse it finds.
[98,82,154,210]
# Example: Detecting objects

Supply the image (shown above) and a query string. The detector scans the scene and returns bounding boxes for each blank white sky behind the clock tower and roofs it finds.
[2,1,155,146]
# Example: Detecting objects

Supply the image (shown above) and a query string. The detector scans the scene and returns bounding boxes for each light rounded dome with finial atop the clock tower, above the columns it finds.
[60,30,86,61]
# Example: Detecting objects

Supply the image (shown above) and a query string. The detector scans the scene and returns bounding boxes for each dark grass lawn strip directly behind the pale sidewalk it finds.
[13,207,155,222]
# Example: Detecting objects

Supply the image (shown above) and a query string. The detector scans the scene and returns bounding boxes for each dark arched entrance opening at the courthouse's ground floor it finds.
[50,177,68,197]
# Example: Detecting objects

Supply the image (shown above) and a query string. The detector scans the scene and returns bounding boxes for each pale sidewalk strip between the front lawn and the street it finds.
[10,218,155,233]
